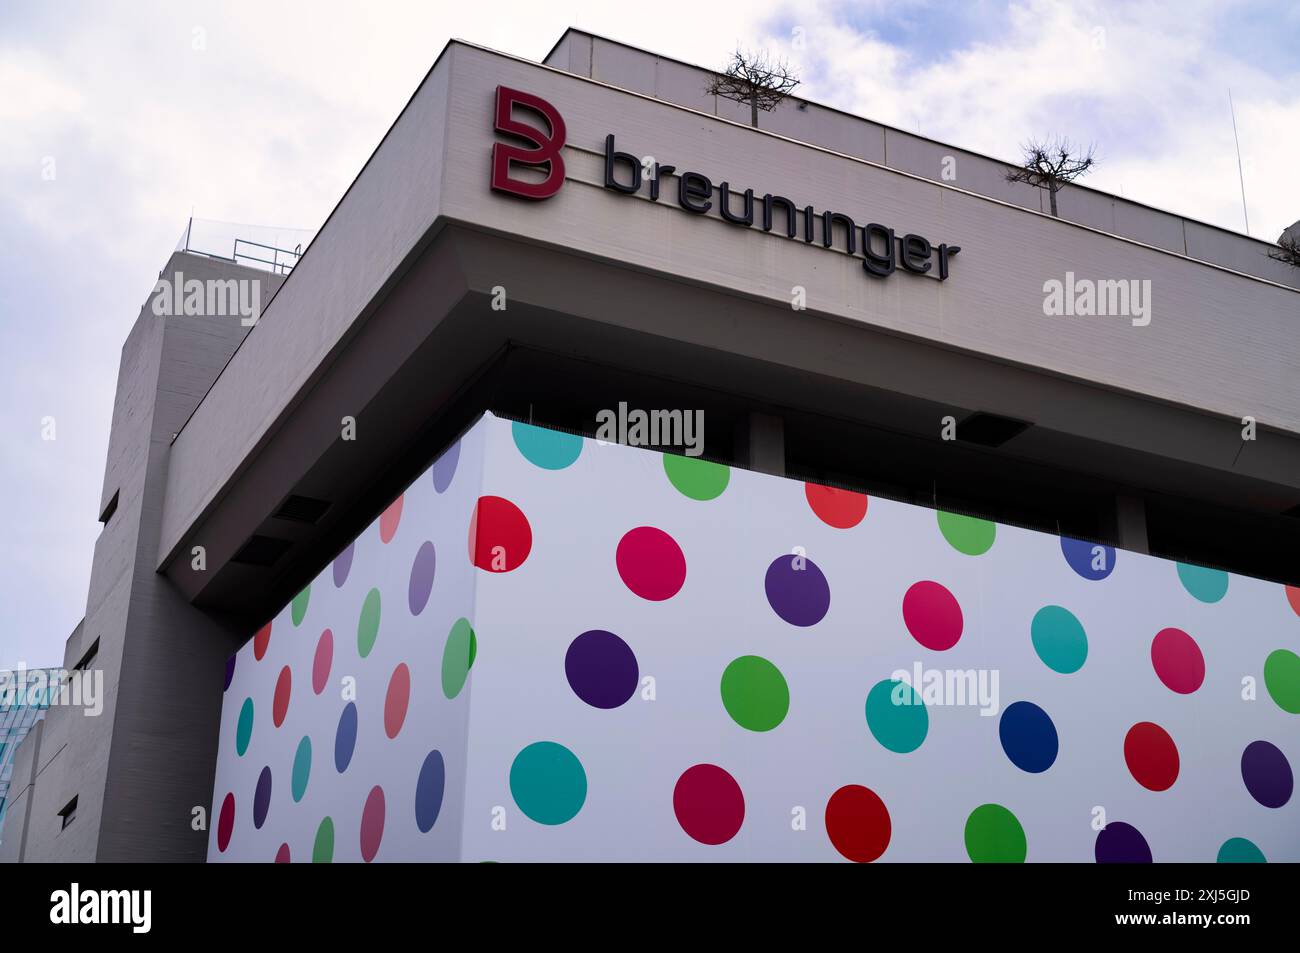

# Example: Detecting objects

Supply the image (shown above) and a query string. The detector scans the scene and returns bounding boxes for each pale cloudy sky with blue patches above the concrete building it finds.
[0,0,1300,667]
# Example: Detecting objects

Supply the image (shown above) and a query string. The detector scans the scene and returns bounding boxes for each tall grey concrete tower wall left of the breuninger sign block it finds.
[7,254,281,862]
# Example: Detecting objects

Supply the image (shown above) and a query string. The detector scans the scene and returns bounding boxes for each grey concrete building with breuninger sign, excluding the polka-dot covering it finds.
[0,30,1300,861]
